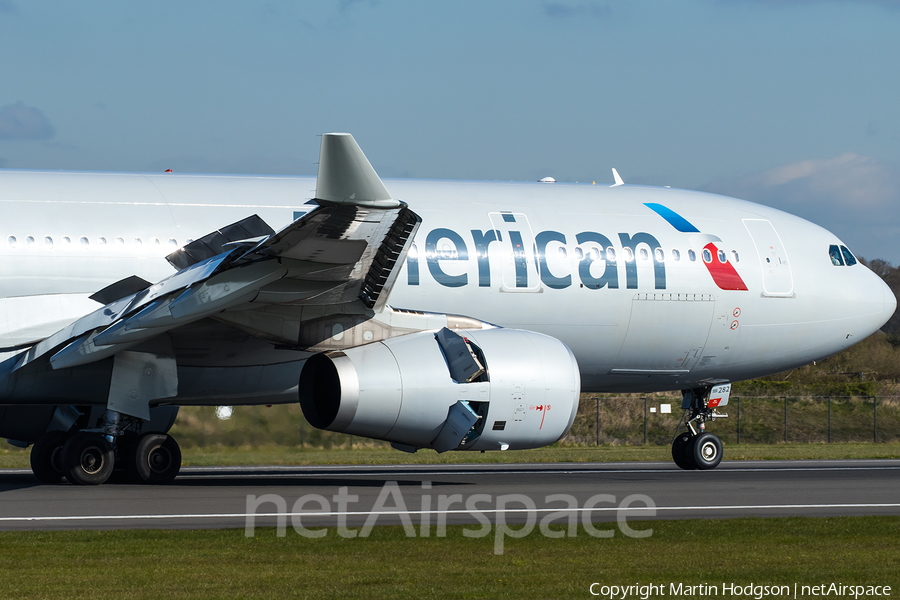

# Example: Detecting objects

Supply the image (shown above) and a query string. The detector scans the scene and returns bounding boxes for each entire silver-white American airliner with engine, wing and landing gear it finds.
[0,134,896,484]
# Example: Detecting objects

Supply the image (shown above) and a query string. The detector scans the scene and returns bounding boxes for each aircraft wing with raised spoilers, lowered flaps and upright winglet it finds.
[12,134,421,371]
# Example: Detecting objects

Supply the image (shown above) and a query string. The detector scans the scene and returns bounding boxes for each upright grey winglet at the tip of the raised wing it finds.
[316,133,400,208]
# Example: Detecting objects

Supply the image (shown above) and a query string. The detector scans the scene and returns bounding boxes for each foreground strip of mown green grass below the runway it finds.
[0,517,900,600]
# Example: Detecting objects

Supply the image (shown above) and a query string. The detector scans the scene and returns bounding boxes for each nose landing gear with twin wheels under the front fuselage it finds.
[672,386,730,470]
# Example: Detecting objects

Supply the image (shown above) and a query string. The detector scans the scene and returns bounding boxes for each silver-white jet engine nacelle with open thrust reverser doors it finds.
[299,328,581,451]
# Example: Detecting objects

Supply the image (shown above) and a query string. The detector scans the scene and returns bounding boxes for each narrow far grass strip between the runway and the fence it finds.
[0,443,900,468]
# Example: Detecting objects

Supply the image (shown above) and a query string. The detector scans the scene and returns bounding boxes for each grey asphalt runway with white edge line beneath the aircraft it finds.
[0,460,900,530]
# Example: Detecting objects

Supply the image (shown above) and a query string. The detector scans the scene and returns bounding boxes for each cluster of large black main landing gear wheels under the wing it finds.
[31,411,181,485]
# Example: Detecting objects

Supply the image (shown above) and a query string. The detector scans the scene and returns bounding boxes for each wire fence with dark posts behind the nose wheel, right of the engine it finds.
[563,394,900,445]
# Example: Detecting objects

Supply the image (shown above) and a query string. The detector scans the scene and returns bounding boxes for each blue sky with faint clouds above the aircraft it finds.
[0,0,900,265]
